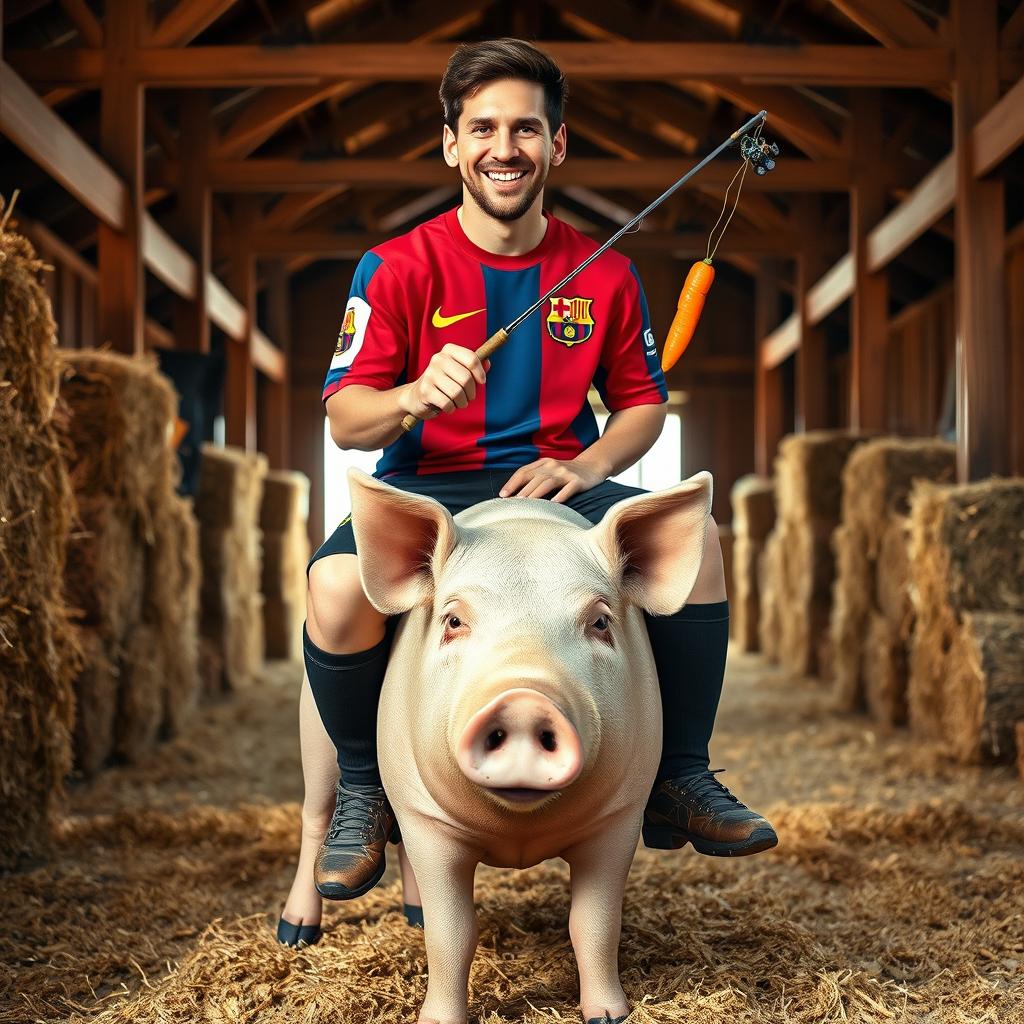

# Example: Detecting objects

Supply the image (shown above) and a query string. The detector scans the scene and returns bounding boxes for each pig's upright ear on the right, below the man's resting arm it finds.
[591,473,712,615]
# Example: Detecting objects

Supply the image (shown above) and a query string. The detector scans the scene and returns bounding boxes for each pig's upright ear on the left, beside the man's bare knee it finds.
[348,469,456,615]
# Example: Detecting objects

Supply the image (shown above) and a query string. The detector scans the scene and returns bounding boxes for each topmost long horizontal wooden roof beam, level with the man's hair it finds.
[8,40,958,88]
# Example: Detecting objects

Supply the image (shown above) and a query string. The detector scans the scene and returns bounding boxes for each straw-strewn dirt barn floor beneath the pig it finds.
[0,655,1024,1024]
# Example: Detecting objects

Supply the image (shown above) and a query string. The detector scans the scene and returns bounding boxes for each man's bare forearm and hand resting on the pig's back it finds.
[501,402,668,502]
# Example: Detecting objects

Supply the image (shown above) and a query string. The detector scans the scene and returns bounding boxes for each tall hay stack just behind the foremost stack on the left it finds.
[61,351,199,760]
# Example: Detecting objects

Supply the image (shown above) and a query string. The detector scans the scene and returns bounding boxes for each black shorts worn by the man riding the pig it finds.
[306,469,647,572]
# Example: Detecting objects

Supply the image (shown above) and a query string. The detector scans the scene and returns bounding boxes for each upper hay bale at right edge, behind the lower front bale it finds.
[907,479,1024,740]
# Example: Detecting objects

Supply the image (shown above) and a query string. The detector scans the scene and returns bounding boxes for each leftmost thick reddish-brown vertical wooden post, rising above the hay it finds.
[97,0,145,354]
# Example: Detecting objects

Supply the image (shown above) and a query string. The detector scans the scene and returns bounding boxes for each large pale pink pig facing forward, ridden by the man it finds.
[349,470,712,1024]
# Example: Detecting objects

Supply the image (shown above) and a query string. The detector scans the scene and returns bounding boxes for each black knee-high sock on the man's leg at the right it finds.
[644,601,729,782]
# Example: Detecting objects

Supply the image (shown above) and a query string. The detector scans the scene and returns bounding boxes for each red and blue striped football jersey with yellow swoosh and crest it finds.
[324,210,668,477]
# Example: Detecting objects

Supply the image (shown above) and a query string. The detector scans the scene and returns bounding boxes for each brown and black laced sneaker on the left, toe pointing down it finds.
[313,782,398,899]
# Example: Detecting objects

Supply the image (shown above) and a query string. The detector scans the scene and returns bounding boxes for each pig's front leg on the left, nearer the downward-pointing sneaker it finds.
[402,827,478,1024]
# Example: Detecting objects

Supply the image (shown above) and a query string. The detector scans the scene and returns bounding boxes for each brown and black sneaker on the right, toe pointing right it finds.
[643,768,778,857]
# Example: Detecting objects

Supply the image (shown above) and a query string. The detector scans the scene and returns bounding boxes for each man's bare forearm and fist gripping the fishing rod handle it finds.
[327,345,490,452]
